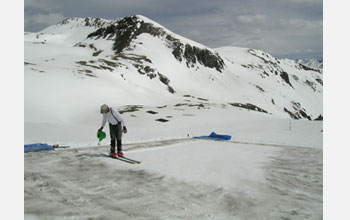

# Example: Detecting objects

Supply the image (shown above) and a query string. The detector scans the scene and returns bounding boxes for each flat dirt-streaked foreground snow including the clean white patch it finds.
[24,134,322,220]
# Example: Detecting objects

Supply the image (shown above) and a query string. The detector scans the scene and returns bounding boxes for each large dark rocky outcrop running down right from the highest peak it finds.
[88,15,225,72]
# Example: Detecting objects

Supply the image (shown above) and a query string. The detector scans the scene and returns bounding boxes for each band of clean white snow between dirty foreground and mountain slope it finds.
[24,102,322,148]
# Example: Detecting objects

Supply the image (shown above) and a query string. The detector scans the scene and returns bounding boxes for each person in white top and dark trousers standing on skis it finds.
[98,104,127,157]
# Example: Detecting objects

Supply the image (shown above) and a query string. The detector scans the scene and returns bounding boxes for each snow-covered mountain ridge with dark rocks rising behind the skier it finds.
[24,15,323,122]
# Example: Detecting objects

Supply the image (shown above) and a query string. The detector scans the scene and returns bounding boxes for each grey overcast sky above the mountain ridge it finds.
[24,0,323,58]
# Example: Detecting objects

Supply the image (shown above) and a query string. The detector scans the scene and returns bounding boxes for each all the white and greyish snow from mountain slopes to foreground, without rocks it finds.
[24,16,323,219]
